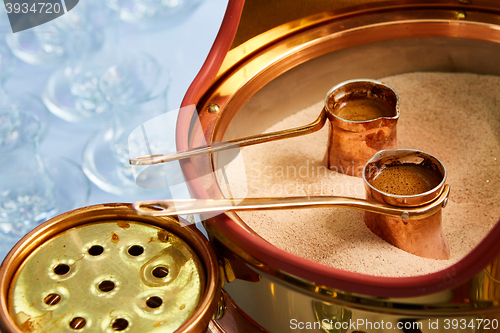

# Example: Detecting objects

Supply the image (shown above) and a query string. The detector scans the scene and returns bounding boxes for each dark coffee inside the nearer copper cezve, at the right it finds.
[370,163,443,195]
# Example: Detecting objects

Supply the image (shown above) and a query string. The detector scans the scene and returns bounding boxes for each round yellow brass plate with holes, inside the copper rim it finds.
[9,220,205,333]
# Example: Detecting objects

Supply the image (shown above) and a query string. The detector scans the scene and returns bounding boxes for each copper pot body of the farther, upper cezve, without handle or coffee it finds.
[325,80,400,177]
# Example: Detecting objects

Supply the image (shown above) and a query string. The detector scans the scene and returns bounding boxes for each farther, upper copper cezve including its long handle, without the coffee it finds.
[130,79,399,177]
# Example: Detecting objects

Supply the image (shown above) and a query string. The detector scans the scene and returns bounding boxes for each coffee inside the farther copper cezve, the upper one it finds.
[334,98,396,121]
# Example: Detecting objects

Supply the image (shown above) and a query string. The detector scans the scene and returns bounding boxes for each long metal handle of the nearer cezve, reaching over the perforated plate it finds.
[132,185,450,220]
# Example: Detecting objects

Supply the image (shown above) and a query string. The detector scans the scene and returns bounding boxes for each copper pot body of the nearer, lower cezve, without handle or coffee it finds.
[363,149,450,259]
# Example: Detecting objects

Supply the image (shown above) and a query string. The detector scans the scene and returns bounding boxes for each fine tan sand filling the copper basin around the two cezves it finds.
[219,73,500,276]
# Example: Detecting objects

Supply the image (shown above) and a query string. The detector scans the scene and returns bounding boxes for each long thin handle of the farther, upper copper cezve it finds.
[130,109,327,165]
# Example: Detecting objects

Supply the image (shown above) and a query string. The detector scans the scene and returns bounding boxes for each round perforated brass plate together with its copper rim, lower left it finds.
[0,204,220,333]
